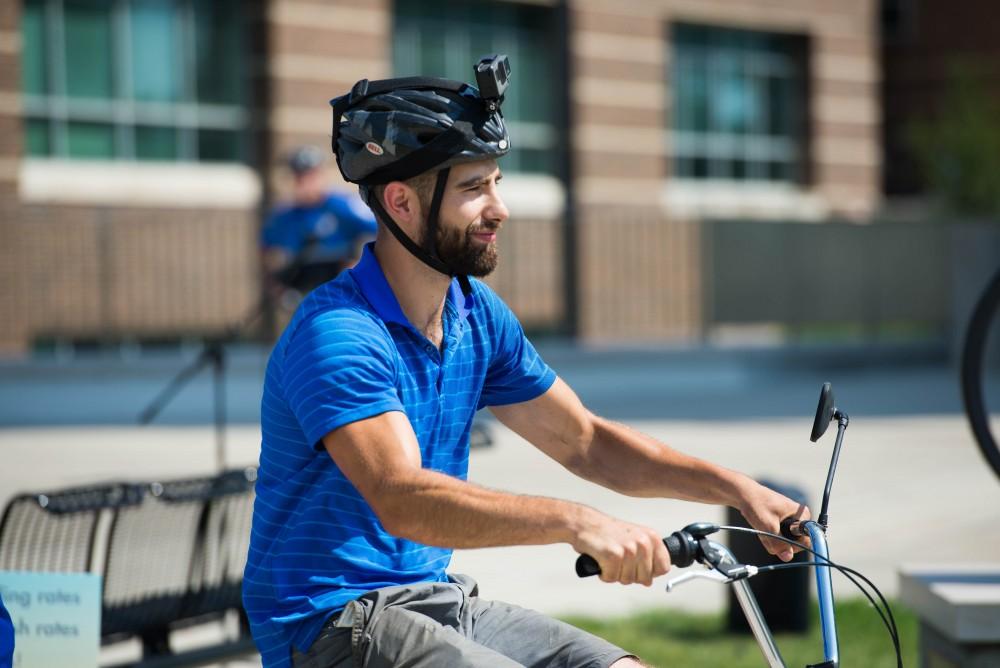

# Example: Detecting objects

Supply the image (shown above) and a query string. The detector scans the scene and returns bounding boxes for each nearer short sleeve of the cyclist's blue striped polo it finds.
[282,310,404,446]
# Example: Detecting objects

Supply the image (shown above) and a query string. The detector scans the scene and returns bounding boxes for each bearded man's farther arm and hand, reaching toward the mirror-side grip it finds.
[490,379,808,560]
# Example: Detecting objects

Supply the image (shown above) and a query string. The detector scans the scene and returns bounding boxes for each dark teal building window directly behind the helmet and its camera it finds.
[393,0,562,174]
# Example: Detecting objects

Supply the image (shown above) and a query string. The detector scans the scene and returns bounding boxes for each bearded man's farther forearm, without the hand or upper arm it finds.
[579,416,751,507]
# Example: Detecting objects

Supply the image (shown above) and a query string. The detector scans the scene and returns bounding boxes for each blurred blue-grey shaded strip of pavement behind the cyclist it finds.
[0,341,962,426]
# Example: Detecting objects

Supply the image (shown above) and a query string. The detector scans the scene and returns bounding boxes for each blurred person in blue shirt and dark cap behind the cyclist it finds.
[261,146,376,311]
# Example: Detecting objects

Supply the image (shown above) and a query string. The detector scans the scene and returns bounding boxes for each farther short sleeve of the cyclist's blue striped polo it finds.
[476,284,556,408]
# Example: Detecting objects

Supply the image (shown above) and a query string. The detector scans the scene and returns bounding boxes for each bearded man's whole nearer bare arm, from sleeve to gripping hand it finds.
[323,411,670,585]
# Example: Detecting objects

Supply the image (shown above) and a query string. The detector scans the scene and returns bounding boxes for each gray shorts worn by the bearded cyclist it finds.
[292,575,632,668]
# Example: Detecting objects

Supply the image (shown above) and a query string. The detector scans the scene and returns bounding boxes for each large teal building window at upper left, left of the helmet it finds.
[21,0,248,162]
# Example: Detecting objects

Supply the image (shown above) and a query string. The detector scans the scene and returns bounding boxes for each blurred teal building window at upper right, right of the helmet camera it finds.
[671,23,808,183]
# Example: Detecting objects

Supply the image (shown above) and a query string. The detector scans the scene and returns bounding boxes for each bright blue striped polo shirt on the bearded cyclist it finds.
[243,244,555,667]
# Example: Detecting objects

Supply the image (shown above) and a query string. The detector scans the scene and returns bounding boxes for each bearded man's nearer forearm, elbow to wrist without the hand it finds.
[370,469,603,548]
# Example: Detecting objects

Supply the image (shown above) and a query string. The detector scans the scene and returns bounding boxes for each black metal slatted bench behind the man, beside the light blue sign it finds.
[0,469,256,668]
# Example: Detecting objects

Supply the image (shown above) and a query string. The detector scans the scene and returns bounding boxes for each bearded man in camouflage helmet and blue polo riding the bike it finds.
[243,64,808,668]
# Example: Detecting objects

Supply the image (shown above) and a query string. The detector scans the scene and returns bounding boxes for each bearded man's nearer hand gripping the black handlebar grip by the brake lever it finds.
[572,511,670,587]
